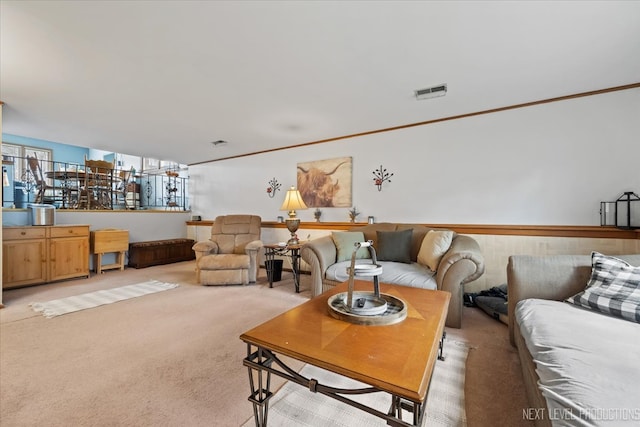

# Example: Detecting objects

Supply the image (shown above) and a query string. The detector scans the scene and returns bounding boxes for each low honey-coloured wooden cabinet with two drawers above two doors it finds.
[2,225,89,289]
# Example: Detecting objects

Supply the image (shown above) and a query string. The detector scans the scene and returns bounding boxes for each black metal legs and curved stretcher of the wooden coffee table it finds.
[242,334,446,427]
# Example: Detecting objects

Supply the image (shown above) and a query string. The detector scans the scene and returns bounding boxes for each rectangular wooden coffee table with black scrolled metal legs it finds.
[240,281,451,426]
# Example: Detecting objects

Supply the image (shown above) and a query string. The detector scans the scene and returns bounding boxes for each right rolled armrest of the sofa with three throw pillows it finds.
[436,234,484,328]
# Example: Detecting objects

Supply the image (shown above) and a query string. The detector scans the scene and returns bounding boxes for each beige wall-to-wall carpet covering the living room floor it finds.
[0,262,531,427]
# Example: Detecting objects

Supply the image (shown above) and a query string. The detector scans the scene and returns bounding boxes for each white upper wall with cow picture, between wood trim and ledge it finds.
[189,88,640,225]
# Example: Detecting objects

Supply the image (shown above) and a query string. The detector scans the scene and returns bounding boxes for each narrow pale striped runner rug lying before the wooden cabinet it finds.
[29,280,178,318]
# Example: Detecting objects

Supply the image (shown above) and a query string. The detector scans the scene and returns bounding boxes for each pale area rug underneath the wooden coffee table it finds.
[243,340,468,427]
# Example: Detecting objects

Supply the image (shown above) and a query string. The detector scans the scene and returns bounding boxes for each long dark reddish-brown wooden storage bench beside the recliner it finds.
[129,239,196,268]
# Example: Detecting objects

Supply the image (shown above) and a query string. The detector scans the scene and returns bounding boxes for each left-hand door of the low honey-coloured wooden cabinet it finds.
[2,239,47,289]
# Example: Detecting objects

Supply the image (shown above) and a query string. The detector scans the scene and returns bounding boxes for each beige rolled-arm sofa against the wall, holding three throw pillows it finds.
[300,222,484,328]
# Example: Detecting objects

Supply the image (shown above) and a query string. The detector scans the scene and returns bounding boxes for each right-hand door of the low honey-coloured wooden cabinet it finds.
[49,236,89,281]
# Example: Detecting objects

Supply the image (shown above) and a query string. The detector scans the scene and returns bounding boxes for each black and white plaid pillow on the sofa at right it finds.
[565,252,640,323]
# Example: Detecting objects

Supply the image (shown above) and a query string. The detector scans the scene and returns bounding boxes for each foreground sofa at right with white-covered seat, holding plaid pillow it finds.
[507,255,640,426]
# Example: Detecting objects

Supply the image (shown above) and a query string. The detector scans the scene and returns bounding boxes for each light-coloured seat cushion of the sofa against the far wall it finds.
[325,260,437,289]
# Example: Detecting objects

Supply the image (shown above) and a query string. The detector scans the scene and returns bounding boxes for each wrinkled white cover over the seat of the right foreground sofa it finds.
[516,299,640,426]
